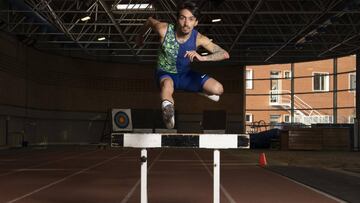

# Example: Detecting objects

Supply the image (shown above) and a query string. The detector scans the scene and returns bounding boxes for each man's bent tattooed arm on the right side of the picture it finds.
[196,33,230,61]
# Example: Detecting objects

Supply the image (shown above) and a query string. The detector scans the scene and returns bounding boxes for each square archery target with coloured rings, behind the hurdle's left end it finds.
[112,109,132,132]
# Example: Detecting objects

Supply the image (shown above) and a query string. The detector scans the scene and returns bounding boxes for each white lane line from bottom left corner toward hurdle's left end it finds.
[7,151,126,203]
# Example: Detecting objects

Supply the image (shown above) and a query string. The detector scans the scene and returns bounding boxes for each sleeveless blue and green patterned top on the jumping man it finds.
[157,24,198,73]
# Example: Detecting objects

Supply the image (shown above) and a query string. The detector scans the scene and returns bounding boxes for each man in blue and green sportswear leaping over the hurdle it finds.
[136,1,229,129]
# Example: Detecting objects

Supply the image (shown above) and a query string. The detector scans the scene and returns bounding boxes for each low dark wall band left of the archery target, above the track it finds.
[0,106,106,146]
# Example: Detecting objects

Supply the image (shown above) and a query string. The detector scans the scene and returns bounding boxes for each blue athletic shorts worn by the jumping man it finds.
[155,69,210,92]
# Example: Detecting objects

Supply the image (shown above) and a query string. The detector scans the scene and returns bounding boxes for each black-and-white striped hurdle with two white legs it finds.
[111,133,250,203]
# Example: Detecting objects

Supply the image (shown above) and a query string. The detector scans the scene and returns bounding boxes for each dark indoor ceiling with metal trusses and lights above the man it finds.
[0,0,360,65]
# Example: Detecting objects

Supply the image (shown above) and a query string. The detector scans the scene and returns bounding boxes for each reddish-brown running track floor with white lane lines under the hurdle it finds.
[0,148,337,203]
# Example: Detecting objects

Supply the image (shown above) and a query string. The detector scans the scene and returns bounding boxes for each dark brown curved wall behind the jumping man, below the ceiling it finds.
[0,33,244,145]
